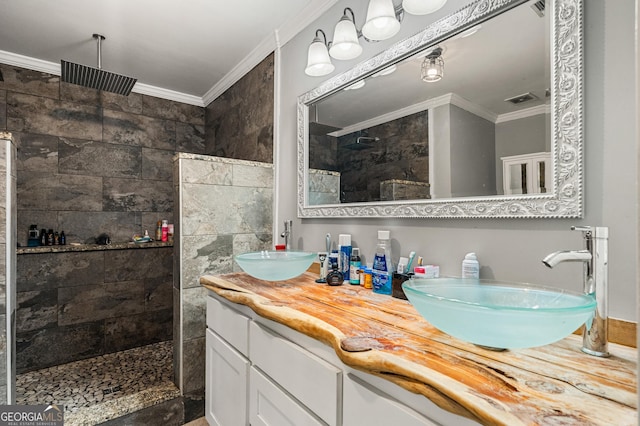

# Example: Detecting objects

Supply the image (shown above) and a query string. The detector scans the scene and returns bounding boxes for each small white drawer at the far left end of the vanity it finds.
[207,296,250,356]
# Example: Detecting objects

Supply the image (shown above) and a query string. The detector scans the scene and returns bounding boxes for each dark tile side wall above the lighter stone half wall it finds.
[205,54,274,163]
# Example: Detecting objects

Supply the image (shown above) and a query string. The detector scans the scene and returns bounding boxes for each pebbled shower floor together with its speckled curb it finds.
[16,341,180,426]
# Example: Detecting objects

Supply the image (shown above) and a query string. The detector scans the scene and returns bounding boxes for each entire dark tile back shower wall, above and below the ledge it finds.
[0,64,205,372]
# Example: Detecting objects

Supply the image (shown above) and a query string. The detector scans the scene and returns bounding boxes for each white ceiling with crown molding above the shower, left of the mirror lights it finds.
[0,0,330,105]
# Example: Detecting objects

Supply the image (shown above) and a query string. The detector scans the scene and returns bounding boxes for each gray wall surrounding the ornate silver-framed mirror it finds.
[275,0,638,321]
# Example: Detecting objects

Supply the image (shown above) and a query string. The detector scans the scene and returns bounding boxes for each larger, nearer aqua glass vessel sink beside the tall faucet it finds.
[402,278,596,349]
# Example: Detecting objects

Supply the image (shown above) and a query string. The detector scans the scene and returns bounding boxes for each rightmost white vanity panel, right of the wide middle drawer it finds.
[342,375,437,426]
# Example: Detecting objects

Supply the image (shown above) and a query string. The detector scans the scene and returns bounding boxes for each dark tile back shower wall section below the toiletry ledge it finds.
[16,247,173,373]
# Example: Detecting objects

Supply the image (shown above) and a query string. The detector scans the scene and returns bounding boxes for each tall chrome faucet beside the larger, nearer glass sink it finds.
[542,226,609,357]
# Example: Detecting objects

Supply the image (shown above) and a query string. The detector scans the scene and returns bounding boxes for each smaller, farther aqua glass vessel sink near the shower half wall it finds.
[235,250,317,281]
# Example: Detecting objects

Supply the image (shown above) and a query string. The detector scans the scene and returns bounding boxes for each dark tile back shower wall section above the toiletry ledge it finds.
[0,64,205,245]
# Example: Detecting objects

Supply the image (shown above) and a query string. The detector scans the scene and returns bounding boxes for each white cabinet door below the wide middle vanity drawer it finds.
[249,367,325,426]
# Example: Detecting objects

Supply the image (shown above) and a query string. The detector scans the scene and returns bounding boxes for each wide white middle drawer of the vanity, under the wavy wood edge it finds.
[249,322,342,425]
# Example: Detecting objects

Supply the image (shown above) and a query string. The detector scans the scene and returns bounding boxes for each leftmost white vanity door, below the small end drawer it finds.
[205,330,250,426]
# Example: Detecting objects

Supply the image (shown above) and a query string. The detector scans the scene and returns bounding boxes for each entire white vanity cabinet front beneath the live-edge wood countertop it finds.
[205,292,472,426]
